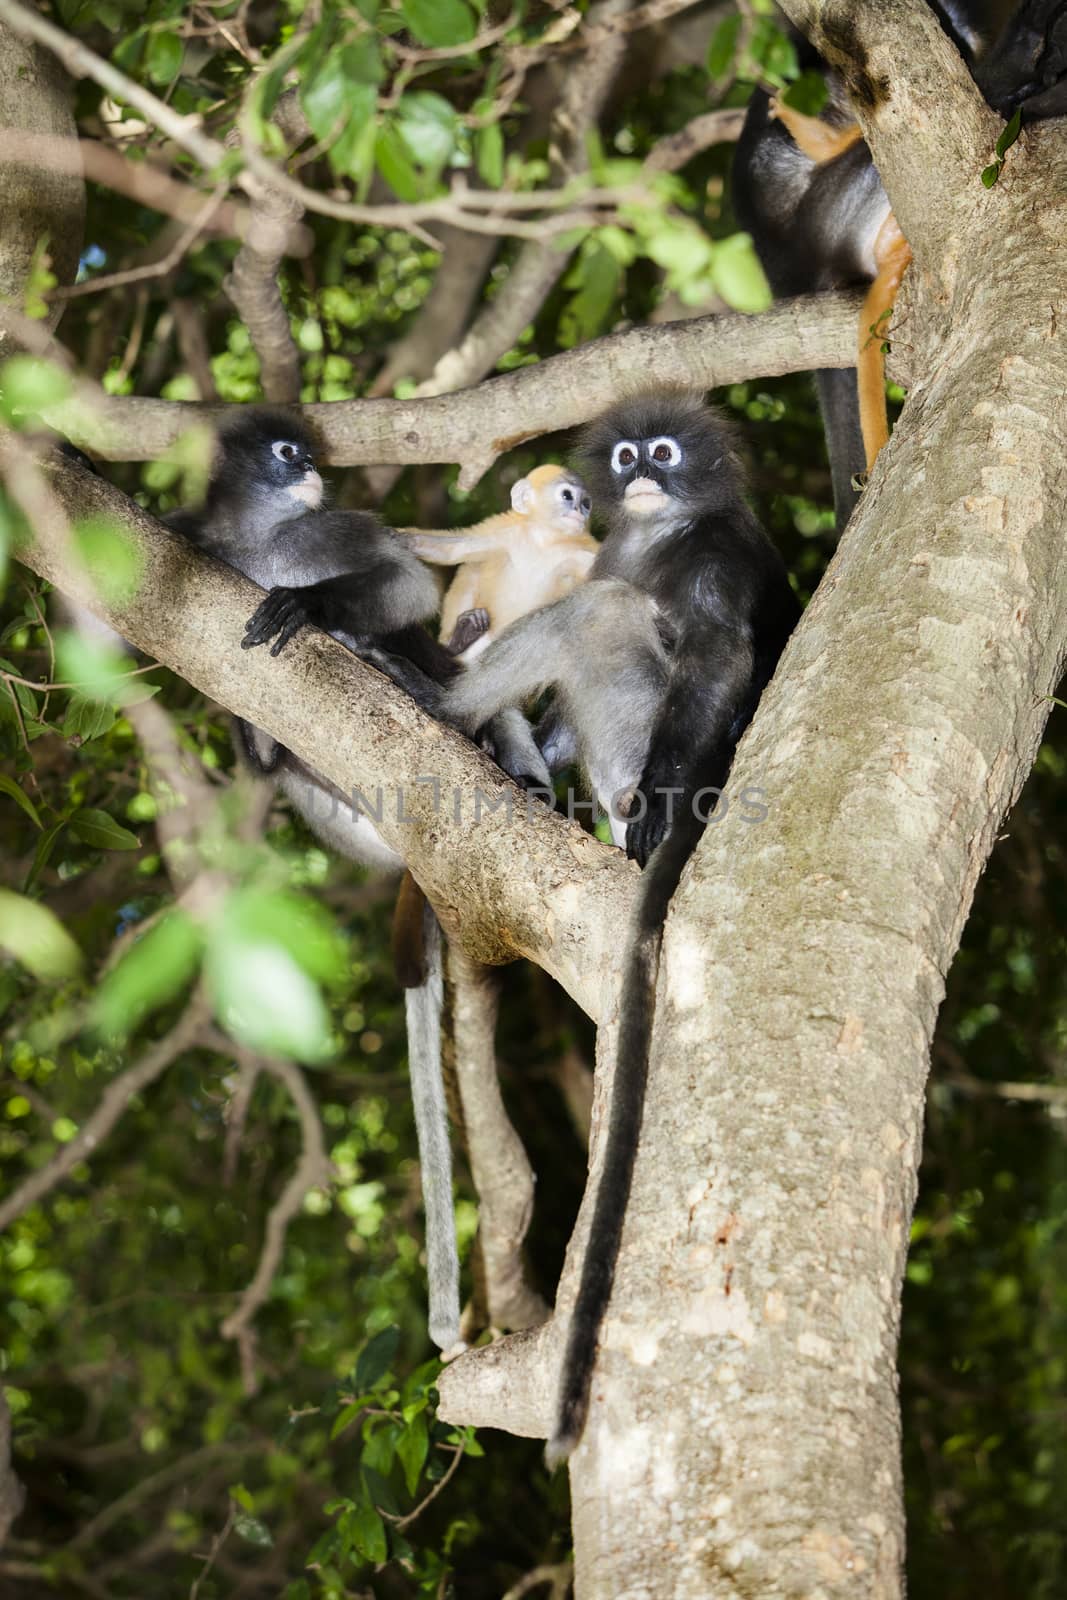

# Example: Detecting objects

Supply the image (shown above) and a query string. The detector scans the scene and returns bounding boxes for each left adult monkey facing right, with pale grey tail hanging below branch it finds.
[168,408,542,1350]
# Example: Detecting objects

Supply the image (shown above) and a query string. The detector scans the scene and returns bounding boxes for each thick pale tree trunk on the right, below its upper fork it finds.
[565,125,1067,1600]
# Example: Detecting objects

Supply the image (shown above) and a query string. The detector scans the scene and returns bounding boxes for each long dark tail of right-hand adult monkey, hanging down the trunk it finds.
[544,786,704,1469]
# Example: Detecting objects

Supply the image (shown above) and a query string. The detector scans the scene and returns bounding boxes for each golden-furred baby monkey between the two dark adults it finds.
[405,466,600,659]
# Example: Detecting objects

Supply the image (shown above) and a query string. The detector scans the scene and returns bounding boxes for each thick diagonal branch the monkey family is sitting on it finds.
[19,462,637,1016]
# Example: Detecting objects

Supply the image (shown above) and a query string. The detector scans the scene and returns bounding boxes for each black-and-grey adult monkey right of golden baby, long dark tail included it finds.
[445,390,800,1461]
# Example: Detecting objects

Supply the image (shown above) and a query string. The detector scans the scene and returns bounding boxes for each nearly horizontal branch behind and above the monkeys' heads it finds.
[41,291,861,485]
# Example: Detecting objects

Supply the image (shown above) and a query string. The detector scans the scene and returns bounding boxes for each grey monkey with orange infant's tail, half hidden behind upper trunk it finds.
[733,0,1067,531]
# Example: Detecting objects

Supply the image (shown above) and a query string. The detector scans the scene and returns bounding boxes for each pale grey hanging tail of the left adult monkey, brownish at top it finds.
[405,902,462,1354]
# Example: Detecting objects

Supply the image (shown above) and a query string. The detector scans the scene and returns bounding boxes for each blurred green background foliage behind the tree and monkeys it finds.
[0,0,1067,1600]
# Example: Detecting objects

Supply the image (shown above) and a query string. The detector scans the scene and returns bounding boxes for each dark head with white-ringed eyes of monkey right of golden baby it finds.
[581,389,741,520]
